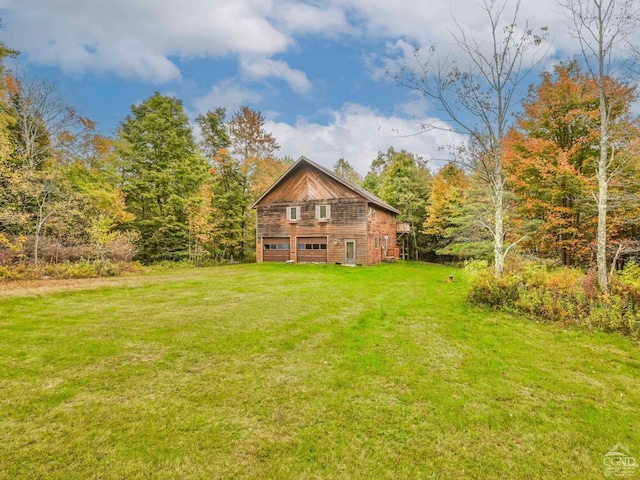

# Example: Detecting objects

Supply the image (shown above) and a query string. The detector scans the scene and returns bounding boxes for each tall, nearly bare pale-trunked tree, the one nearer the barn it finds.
[394,0,545,276]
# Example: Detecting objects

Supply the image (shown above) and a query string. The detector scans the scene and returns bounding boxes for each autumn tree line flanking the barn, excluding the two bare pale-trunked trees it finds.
[0,61,640,274]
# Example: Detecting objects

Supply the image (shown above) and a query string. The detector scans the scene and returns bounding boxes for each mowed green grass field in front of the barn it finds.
[0,263,640,480]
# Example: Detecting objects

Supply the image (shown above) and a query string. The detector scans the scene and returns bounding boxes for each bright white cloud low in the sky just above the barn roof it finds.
[265,104,463,175]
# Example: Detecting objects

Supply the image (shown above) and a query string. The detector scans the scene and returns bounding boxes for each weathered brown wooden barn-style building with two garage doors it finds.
[252,157,404,265]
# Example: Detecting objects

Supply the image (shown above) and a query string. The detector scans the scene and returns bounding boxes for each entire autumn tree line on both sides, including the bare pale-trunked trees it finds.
[0,0,640,289]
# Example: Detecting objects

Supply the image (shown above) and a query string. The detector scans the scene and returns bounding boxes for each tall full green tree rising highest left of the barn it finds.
[118,92,207,262]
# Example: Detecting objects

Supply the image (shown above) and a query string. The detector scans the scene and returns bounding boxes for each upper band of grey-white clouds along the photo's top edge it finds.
[0,0,624,93]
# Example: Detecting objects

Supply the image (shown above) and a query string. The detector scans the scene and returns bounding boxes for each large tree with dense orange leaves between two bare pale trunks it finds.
[505,61,634,265]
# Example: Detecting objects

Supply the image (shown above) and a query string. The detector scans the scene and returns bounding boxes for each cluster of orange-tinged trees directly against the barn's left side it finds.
[192,106,287,262]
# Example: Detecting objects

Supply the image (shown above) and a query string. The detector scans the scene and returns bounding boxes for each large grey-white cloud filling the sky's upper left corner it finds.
[3,0,291,82]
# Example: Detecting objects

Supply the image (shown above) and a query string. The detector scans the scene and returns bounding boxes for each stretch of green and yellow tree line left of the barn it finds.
[0,64,291,266]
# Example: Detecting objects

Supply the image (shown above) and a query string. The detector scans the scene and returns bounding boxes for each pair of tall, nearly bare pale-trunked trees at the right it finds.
[392,0,640,293]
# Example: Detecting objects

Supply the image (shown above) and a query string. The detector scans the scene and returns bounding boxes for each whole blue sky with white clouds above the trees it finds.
[0,0,632,173]
